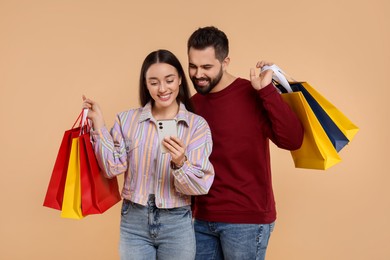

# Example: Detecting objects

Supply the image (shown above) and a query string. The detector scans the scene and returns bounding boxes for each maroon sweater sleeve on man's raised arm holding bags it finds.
[258,83,304,150]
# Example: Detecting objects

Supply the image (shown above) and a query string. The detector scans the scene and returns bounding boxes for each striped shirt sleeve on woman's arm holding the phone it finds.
[171,117,214,195]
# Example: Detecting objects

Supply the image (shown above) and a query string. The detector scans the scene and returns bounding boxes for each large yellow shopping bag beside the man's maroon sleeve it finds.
[282,92,341,170]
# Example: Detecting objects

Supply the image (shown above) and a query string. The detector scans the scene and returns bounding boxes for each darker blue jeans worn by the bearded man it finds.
[194,220,275,260]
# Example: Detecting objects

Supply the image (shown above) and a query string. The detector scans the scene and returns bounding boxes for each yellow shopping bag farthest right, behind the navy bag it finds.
[302,82,359,141]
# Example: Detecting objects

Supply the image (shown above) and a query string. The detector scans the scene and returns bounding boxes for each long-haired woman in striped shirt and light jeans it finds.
[83,50,214,260]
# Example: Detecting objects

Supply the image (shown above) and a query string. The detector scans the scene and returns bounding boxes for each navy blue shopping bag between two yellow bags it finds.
[282,82,349,152]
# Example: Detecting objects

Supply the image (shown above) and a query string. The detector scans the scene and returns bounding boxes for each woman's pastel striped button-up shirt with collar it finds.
[92,102,214,208]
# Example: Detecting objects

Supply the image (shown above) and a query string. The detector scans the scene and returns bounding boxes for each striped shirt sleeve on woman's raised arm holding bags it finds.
[91,116,128,178]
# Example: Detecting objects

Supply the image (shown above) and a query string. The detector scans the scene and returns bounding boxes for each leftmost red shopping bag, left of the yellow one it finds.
[43,113,82,210]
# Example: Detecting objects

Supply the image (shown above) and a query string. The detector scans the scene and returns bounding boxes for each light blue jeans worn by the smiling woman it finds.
[119,195,196,260]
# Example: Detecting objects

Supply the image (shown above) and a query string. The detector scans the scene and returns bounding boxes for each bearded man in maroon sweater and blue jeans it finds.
[187,27,303,260]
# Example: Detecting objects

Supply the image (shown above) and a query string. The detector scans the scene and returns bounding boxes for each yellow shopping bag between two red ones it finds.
[61,137,83,219]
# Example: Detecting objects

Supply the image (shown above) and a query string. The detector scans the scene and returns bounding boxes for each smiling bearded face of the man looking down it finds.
[188,47,223,95]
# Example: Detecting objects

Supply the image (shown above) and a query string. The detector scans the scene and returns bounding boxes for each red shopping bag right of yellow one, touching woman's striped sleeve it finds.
[79,126,121,216]
